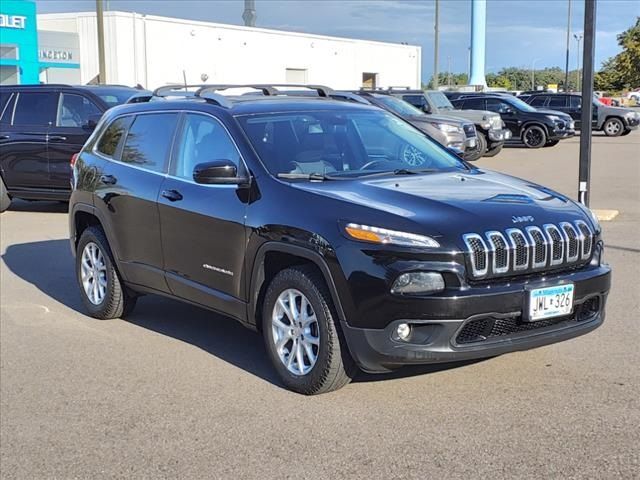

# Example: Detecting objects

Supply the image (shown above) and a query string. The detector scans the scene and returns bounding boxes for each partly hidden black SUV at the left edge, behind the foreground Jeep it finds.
[0,84,139,212]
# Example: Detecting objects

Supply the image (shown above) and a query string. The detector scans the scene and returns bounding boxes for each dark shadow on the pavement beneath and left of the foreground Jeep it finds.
[2,239,484,388]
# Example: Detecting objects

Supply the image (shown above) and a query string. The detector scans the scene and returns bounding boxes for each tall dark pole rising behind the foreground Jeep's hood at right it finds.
[578,0,596,207]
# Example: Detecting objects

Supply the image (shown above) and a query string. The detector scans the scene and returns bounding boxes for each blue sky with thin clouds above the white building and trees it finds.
[36,0,640,81]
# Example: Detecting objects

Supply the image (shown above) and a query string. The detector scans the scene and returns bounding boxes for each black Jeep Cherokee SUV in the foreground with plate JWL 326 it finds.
[69,86,610,394]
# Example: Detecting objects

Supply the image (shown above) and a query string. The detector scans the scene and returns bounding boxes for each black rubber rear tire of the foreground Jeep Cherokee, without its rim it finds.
[76,227,136,320]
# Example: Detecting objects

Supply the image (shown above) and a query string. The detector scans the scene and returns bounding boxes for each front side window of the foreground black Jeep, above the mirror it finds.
[171,113,241,180]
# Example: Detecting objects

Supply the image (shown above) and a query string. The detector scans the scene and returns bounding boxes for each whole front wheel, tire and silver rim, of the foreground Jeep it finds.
[262,266,356,395]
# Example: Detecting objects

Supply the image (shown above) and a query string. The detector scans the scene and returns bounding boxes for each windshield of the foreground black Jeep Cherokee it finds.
[237,110,467,179]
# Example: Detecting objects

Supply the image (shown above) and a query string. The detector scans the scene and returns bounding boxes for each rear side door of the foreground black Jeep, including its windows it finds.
[94,112,180,291]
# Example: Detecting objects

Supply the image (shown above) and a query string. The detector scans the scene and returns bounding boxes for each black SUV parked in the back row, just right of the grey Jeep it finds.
[451,94,576,148]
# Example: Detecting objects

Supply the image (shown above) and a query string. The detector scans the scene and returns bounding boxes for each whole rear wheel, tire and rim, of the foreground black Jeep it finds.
[76,227,136,320]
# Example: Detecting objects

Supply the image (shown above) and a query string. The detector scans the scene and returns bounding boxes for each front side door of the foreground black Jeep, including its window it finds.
[158,112,247,318]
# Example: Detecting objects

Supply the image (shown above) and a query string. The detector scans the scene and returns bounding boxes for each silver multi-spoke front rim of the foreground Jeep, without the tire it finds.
[271,288,320,375]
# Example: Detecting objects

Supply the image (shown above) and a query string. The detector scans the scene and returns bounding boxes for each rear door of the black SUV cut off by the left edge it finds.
[0,90,58,190]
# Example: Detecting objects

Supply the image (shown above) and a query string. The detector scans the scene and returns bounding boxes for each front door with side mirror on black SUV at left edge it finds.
[49,92,102,190]
